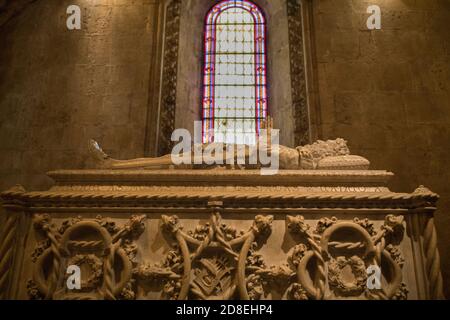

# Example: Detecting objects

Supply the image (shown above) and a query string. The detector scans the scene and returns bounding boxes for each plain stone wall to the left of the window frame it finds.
[0,0,155,189]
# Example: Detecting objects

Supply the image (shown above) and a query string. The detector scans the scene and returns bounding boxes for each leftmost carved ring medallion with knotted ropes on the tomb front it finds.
[27,214,145,300]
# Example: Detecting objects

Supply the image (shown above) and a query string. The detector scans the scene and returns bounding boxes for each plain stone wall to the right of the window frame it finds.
[313,0,450,294]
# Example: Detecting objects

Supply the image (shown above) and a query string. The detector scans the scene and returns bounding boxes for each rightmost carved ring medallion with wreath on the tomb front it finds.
[287,215,407,299]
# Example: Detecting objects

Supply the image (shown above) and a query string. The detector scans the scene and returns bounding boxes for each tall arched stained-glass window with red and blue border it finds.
[202,0,267,144]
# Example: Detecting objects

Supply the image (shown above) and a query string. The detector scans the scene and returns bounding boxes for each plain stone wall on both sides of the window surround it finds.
[0,0,450,293]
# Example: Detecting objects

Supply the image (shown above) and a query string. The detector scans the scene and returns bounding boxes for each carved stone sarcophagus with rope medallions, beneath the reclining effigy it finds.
[0,170,442,300]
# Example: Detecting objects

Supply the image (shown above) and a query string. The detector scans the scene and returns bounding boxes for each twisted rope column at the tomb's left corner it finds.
[0,214,18,299]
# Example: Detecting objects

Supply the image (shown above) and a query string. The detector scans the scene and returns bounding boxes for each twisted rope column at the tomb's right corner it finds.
[423,218,444,300]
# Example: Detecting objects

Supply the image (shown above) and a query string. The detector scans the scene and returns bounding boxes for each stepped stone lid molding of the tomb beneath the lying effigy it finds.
[0,170,439,211]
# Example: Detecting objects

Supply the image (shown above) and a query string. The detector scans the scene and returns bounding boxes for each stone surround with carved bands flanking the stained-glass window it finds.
[145,0,321,156]
